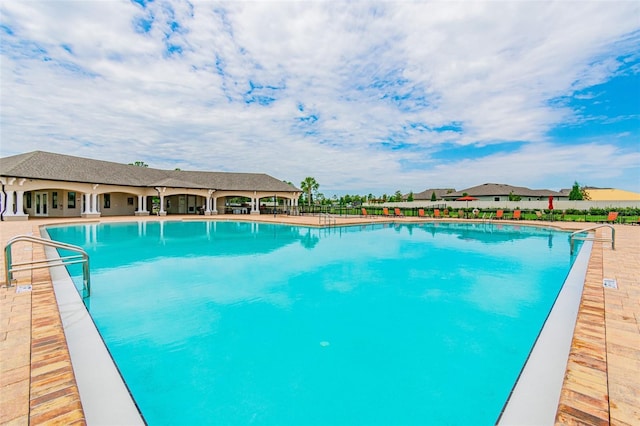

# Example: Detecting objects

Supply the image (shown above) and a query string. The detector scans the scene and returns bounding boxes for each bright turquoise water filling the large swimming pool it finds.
[47,221,584,425]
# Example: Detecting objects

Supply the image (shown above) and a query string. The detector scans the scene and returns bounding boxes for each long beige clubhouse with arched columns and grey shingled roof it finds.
[0,151,301,220]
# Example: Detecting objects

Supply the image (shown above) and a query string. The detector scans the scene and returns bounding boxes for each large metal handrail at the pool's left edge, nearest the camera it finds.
[4,235,91,297]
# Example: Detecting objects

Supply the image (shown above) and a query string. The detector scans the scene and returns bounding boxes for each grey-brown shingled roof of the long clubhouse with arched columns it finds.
[0,151,300,192]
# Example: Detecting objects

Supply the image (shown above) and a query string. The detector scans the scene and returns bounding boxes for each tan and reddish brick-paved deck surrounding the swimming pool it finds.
[0,215,640,425]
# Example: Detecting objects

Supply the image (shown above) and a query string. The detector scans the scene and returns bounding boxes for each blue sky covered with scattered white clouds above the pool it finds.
[0,0,640,196]
